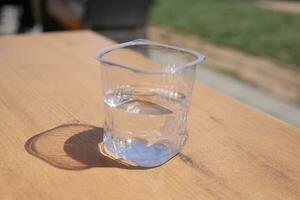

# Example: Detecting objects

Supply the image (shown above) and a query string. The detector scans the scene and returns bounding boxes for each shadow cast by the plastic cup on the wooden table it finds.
[25,123,145,170]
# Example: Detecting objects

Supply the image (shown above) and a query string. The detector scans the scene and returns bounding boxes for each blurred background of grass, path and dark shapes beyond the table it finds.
[0,0,300,127]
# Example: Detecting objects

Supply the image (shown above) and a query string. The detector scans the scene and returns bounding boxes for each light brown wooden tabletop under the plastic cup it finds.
[0,31,300,200]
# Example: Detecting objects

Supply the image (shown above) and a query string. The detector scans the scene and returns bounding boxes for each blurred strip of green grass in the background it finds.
[150,0,300,67]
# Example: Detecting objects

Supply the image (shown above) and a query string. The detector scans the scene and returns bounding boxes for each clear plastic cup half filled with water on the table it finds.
[97,39,204,167]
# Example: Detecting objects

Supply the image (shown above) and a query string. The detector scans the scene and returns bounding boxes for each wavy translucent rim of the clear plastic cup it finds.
[95,39,205,74]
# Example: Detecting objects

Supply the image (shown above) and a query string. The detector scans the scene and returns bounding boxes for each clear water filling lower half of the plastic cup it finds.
[104,85,189,167]
